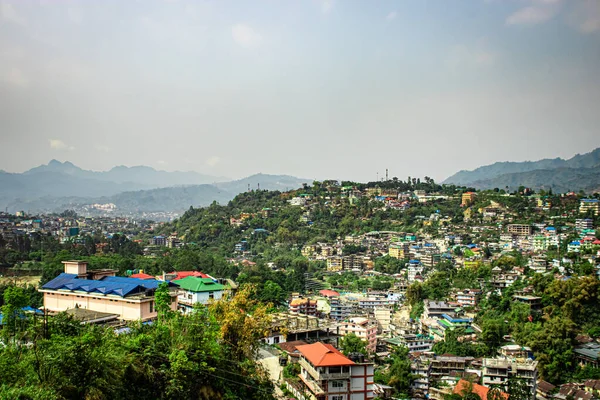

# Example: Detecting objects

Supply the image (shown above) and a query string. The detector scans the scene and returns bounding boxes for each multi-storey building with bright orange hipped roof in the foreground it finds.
[296,342,375,400]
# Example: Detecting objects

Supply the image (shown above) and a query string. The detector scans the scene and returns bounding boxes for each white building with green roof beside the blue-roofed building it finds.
[173,276,226,313]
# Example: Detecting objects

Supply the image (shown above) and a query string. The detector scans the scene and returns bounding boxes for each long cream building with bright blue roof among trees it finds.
[39,261,177,321]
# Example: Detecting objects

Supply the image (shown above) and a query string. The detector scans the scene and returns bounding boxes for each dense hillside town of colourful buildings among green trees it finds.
[0,180,600,400]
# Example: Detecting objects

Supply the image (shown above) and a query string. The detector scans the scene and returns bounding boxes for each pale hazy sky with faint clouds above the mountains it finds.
[0,0,600,180]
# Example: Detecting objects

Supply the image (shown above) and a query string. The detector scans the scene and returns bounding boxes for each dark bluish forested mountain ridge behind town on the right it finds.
[443,148,600,192]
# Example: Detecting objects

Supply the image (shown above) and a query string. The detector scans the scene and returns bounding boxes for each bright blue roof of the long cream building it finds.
[42,273,172,297]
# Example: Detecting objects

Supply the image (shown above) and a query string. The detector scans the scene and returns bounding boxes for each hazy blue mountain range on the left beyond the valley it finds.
[0,160,309,214]
